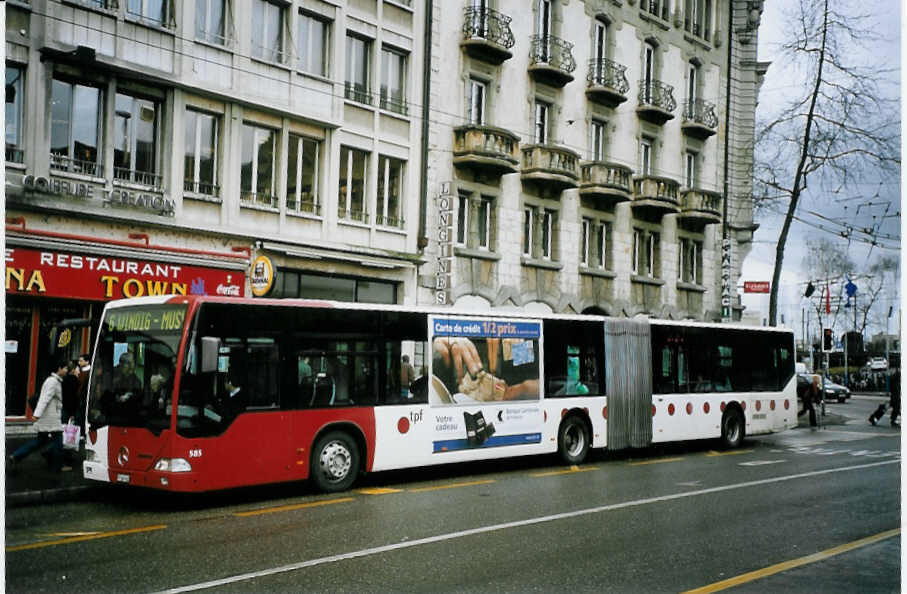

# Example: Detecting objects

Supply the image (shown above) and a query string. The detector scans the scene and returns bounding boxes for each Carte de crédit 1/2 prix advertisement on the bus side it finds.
[429,317,542,453]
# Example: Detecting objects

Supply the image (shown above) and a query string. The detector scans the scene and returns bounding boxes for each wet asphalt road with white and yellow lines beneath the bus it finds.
[6,399,900,592]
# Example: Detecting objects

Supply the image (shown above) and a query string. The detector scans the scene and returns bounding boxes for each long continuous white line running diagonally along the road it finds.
[156,460,899,594]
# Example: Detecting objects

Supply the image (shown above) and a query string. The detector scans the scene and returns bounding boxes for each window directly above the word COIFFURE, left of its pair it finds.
[50,78,104,177]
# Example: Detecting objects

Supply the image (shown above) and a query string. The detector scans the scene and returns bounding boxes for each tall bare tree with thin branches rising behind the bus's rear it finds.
[755,0,900,326]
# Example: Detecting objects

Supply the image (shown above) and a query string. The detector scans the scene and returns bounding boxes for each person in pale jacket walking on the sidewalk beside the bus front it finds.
[8,361,72,472]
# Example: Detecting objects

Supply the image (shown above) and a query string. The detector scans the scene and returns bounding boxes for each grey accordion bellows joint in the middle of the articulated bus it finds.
[605,319,652,450]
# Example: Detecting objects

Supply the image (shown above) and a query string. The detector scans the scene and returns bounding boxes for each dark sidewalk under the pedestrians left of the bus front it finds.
[6,433,99,507]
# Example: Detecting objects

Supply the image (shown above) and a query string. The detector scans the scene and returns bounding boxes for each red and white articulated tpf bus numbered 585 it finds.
[83,296,797,492]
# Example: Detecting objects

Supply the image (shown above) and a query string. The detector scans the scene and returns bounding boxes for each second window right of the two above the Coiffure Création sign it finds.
[240,123,278,208]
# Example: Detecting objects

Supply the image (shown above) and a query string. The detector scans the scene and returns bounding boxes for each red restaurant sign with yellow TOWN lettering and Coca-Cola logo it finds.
[6,247,246,301]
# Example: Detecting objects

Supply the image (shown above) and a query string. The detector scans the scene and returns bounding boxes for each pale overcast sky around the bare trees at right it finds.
[741,0,904,335]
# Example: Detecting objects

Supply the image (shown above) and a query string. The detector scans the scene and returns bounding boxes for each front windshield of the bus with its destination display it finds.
[88,304,187,434]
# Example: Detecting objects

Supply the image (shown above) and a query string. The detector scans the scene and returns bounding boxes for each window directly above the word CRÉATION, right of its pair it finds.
[113,93,163,189]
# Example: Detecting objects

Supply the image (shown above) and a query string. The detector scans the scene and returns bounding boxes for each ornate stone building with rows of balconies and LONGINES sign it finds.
[420,0,766,320]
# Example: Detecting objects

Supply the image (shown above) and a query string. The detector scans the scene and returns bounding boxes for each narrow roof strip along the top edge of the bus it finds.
[106,295,793,333]
